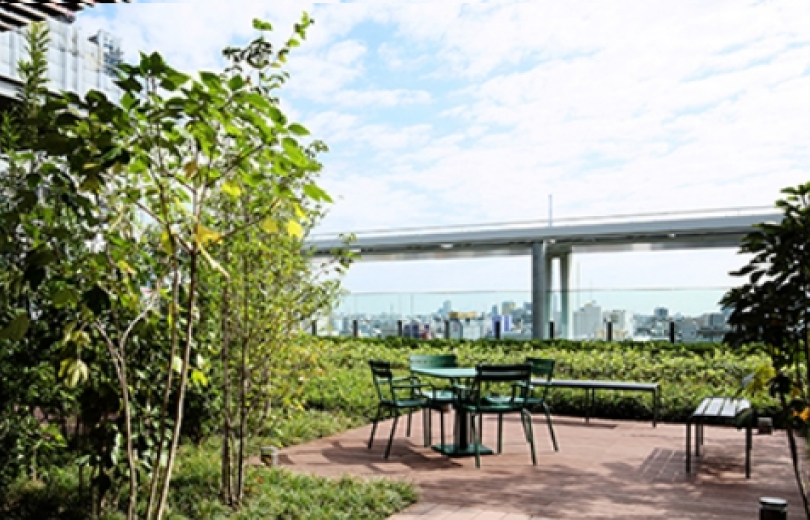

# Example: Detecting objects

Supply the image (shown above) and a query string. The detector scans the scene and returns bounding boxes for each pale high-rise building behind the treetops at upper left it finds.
[0,20,123,101]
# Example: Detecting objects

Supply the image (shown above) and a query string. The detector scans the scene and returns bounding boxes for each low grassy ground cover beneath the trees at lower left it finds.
[6,430,417,520]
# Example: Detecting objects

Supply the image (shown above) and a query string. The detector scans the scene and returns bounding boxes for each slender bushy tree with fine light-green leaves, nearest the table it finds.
[205,159,351,508]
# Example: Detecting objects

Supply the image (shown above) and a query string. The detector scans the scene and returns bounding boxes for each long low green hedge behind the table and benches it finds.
[305,338,778,422]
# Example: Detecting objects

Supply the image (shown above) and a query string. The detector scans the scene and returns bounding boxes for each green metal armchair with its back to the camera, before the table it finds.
[454,363,537,468]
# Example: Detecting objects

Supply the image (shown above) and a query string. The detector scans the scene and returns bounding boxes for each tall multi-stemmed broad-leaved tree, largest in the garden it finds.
[0,14,346,518]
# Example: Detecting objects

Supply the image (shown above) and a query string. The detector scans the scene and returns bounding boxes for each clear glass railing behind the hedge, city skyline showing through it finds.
[310,287,728,342]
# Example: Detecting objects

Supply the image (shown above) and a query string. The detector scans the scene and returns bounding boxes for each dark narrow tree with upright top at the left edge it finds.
[0,20,87,496]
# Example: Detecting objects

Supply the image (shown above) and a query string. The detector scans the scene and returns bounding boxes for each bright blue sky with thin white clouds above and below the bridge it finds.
[77,0,810,310]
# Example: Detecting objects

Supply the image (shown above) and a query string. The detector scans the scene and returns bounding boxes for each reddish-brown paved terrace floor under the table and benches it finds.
[270,414,801,520]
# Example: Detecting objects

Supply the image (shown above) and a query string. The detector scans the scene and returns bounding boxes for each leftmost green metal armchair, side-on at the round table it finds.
[368,360,430,459]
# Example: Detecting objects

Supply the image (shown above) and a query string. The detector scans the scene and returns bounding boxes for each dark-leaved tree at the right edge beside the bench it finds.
[721,183,810,518]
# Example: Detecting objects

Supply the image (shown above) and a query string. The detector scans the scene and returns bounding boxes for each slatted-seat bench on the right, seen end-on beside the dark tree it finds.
[686,397,754,478]
